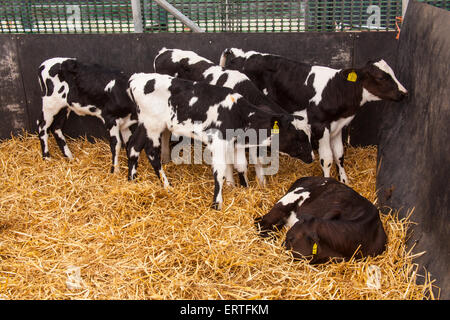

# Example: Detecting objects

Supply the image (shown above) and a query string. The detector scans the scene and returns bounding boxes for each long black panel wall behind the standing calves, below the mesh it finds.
[0,32,397,145]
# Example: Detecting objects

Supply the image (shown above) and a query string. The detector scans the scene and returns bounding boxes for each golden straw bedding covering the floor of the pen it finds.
[0,134,435,299]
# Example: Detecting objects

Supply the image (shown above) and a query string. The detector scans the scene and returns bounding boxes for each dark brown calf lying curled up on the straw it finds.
[256,177,387,263]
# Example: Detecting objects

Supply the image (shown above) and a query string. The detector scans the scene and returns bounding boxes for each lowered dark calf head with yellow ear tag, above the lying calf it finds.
[271,114,313,163]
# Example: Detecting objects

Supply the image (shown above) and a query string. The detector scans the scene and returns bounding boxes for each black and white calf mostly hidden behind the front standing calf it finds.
[153,48,314,186]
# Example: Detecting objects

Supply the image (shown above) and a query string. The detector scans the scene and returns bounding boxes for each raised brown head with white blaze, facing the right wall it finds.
[359,59,408,101]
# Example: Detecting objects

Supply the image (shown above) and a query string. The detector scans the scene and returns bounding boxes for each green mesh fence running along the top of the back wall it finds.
[0,0,450,33]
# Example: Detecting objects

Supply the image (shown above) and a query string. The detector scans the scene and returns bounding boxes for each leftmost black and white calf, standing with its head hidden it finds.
[37,58,137,172]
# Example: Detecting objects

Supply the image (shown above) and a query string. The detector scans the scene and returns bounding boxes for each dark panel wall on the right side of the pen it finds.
[377,1,450,299]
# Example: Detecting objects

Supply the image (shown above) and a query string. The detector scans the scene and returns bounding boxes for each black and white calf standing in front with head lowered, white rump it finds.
[128,73,312,209]
